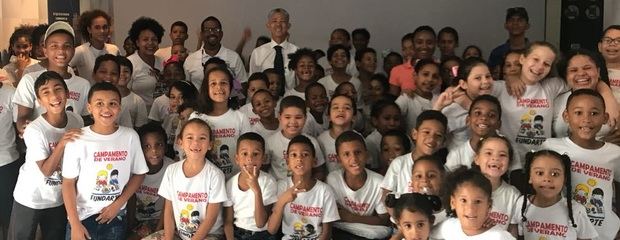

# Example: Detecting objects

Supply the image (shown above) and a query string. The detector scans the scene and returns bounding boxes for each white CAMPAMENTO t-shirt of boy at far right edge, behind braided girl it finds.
[541,137,620,239]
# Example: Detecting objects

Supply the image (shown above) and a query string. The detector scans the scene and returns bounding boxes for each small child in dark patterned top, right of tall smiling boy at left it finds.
[127,123,174,239]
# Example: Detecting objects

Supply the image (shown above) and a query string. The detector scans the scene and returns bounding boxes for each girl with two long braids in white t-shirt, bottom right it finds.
[506,150,598,240]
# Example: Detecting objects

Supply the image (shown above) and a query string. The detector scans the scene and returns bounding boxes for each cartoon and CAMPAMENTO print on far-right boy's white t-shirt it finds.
[571,161,612,227]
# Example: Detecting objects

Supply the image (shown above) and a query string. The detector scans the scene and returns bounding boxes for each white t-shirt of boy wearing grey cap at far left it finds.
[13,70,90,120]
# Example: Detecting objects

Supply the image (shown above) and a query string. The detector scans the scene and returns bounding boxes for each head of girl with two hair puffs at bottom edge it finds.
[385,193,441,240]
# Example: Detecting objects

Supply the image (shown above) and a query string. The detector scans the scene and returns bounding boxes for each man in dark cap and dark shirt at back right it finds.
[488,7,530,76]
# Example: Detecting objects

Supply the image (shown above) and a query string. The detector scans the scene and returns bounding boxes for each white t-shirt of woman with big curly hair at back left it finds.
[127,52,164,111]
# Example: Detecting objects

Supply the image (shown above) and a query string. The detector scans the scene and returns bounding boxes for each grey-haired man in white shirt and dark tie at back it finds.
[250,8,298,90]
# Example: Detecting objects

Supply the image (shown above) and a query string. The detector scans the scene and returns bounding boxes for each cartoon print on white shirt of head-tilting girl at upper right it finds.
[515,108,550,145]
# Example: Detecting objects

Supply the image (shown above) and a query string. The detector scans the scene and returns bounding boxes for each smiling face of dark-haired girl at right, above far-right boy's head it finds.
[566,55,600,90]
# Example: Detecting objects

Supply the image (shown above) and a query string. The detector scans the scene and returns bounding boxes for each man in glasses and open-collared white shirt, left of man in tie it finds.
[183,16,247,89]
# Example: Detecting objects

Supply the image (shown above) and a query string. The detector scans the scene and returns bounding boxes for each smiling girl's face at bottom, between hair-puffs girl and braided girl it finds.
[450,182,491,236]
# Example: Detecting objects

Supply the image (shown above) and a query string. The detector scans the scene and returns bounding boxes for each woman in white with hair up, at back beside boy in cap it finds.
[69,9,120,85]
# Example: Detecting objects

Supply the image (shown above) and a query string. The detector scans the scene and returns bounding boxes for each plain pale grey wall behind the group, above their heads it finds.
[113,0,545,60]
